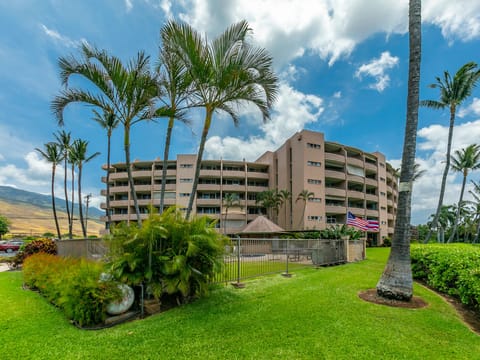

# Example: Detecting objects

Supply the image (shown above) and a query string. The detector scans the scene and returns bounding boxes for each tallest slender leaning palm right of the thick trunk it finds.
[420,62,480,242]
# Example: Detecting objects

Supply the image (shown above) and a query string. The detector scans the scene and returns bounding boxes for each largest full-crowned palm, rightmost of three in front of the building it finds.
[162,21,278,219]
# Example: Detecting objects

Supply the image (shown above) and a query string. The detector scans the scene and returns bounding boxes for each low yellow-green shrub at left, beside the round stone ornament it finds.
[23,253,121,326]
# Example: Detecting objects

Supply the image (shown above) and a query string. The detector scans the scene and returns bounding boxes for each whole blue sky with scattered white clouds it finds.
[0,0,480,224]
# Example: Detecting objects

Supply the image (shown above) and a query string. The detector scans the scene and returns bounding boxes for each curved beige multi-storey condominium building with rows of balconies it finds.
[102,130,398,243]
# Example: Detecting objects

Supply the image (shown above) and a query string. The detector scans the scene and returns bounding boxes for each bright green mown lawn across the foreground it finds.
[0,249,480,360]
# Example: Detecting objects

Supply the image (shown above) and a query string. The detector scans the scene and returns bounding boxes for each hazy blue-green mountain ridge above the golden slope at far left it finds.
[0,186,105,219]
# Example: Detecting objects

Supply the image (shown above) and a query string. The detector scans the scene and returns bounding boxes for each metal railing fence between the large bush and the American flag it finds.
[214,238,348,283]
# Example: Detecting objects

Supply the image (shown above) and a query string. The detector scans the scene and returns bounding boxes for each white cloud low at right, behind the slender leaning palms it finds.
[389,120,480,224]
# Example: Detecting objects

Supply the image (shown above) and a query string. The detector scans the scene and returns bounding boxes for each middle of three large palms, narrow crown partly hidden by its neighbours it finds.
[156,34,192,214]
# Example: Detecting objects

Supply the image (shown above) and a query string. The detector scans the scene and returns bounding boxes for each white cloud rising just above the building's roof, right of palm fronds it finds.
[205,83,324,161]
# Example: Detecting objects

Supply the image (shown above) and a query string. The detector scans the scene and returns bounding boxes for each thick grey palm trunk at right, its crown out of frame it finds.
[376,0,422,301]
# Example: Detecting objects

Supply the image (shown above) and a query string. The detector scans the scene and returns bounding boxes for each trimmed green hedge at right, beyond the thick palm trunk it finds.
[411,244,480,307]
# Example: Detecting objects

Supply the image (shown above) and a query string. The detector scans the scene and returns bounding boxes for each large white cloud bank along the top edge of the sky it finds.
[175,0,480,67]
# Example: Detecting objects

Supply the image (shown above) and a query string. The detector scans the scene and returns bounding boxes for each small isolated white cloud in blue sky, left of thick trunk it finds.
[355,51,399,92]
